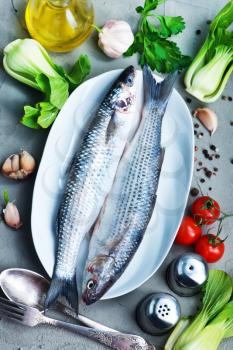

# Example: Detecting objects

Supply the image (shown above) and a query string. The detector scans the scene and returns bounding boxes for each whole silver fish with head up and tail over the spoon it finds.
[45,66,136,310]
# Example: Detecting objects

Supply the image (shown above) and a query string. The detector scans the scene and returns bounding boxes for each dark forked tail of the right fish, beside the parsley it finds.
[143,64,178,108]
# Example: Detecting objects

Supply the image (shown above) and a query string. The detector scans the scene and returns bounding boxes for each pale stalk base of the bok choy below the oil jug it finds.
[3,39,61,90]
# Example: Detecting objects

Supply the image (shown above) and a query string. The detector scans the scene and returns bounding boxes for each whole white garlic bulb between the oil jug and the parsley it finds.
[98,19,134,58]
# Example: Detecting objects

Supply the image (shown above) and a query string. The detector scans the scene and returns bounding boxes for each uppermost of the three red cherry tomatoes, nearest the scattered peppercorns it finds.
[191,196,220,225]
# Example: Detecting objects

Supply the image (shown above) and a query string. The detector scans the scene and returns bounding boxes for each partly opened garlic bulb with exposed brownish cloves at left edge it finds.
[2,151,36,180]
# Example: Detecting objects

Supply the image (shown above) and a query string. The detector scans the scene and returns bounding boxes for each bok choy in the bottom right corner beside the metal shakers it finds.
[165,270,233,350]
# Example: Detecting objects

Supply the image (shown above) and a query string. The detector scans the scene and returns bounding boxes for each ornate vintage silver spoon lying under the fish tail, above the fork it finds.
[0,268,117,332]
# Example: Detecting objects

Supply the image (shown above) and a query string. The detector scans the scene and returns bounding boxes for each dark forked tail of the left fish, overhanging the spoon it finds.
[44,275,79,313]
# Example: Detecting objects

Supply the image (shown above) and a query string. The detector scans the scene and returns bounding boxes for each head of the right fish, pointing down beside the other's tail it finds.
[82,255,114,305]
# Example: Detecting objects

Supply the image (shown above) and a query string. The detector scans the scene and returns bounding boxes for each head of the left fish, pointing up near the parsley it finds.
[110,66,136,115]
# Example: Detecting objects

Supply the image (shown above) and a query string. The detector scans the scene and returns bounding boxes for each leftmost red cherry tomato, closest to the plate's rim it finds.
[175,216,202,245]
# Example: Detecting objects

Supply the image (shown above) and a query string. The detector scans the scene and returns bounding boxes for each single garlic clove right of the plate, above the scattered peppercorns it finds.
[194,107,218,135]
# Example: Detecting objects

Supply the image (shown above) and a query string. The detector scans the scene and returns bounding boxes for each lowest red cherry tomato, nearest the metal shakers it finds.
[195,234,225,263]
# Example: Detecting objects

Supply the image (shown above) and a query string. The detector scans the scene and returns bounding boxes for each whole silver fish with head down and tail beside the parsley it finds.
[82,66,176,305]
